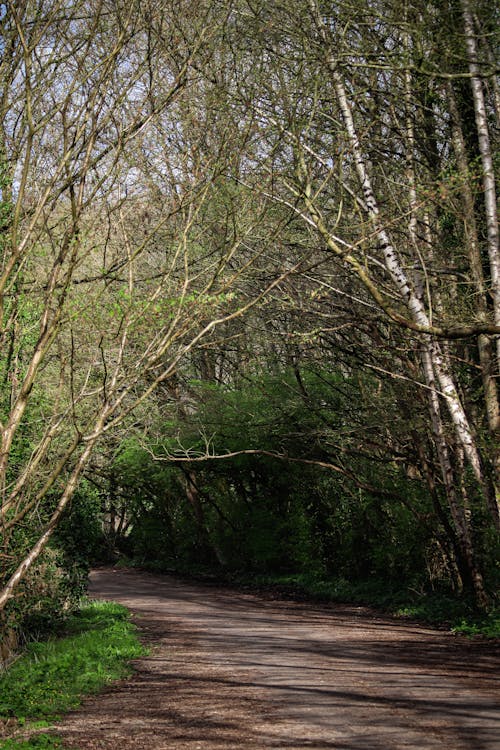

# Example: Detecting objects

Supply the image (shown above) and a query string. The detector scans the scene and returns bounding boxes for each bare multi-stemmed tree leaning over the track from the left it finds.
[0,0,300,608]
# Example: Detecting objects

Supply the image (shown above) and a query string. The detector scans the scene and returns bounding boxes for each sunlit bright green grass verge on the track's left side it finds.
[0,602,144,750]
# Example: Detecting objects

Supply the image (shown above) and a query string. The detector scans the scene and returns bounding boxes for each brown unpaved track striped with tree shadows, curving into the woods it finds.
[52,569,500,750]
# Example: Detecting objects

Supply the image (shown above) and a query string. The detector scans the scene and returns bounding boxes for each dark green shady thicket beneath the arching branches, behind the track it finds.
[99,370,498,612]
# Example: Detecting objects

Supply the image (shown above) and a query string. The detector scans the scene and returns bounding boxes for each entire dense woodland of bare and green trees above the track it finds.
[0,0,500,648]
